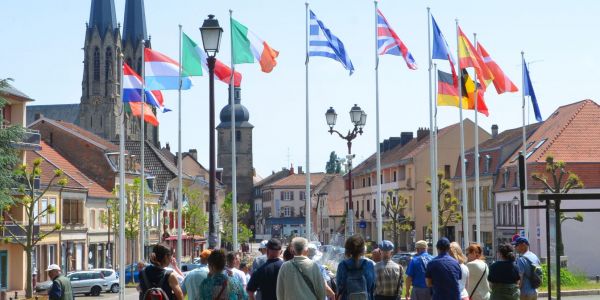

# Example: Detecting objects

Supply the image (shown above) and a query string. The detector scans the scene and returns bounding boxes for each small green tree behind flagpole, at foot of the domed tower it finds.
[219,193,252,247]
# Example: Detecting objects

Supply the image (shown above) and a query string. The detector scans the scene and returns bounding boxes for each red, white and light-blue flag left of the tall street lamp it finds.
[144,48,192,91]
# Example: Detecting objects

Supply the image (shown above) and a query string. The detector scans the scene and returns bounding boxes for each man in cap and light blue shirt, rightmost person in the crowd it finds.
[512,237,540,300]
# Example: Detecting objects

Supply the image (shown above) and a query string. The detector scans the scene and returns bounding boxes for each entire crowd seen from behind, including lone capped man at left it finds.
[42,235,540,300]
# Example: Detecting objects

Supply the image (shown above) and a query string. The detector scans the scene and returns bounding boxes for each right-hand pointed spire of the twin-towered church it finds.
[123,0,148,48]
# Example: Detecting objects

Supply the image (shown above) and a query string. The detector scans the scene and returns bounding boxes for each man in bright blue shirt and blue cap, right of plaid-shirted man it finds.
[405,240,433,300]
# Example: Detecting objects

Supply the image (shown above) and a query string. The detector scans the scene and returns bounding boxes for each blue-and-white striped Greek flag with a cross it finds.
[308,10,354,75]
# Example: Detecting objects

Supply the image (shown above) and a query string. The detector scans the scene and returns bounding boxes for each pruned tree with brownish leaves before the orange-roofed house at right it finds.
[531,155,583,256]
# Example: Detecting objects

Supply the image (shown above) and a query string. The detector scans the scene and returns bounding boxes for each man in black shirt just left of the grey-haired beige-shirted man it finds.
[246,239,283,300]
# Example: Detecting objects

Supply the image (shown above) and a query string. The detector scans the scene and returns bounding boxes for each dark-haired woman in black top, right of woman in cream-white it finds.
[488,244,519,300]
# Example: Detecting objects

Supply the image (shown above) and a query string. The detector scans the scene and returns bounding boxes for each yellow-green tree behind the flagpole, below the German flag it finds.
[425,172,462,238]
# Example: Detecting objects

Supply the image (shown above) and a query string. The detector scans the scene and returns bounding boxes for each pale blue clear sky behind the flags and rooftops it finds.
[0,0,600,177]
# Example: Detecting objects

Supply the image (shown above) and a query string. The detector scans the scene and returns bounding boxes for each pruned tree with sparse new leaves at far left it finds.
[4,158,68,298]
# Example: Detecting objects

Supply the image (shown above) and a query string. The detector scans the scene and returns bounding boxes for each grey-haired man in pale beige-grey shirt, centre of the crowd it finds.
[277,237,325,300]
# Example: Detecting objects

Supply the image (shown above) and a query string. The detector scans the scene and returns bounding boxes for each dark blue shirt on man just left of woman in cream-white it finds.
[425,252,462,300]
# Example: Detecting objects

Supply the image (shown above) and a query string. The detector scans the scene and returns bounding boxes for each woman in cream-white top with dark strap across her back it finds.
[467,244,490,300]
